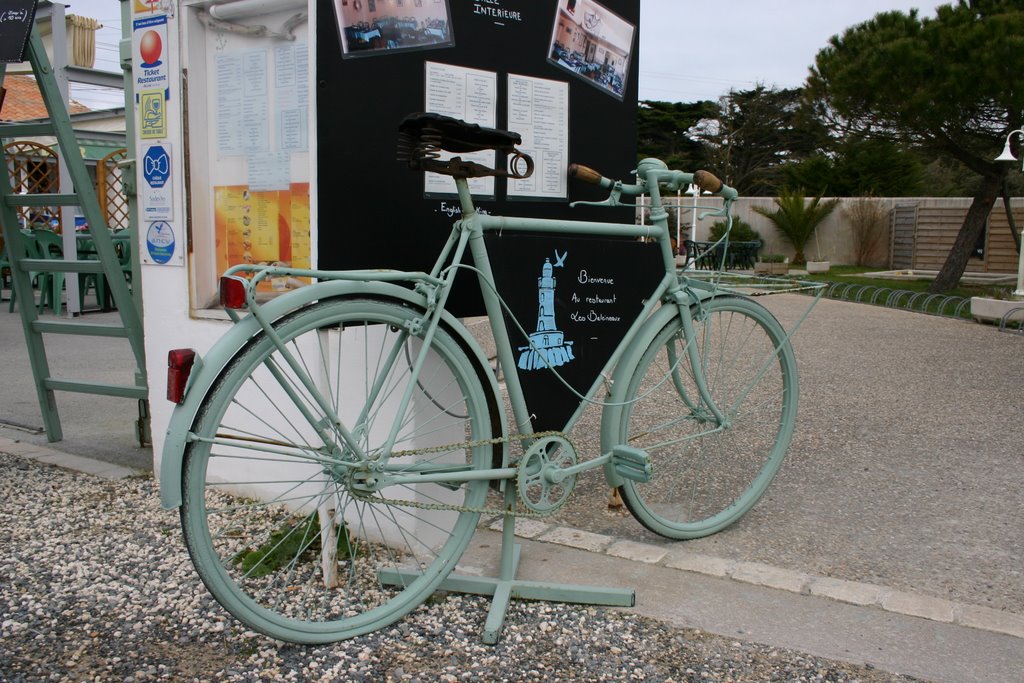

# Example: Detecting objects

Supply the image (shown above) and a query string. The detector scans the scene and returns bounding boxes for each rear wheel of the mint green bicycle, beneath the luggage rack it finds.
[181,299,496,643]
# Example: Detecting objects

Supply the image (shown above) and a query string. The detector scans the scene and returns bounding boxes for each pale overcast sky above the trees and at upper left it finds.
[65,0,942,106]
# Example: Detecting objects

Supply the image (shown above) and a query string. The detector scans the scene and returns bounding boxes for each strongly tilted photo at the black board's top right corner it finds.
[548,0,636,99]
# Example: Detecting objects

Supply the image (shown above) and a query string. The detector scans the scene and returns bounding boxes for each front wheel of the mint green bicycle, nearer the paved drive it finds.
[618,296,799,539]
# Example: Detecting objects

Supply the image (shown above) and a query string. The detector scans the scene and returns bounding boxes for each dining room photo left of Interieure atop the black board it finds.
[334,0,455,57]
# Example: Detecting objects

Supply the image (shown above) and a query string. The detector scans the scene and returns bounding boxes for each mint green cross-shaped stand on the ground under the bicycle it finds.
[379,485,636,645]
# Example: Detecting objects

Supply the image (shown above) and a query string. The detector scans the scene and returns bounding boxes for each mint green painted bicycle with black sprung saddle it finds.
[161,114,798,643]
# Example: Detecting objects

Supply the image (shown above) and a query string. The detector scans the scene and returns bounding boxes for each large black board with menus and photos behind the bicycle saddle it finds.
[315,0,640,313]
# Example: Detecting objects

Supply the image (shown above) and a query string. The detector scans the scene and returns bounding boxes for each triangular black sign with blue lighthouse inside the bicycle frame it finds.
[485,233,665,430]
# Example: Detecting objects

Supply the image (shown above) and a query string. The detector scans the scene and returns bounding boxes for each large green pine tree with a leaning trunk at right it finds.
[806,0,1024,292]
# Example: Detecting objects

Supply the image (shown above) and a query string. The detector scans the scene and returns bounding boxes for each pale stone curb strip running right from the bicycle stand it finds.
[486,517,1024,639]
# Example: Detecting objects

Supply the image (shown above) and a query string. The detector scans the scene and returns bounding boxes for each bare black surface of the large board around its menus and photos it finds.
[319,0,640,315]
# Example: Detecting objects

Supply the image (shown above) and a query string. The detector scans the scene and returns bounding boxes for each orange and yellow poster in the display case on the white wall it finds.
[213,182,311,290]
